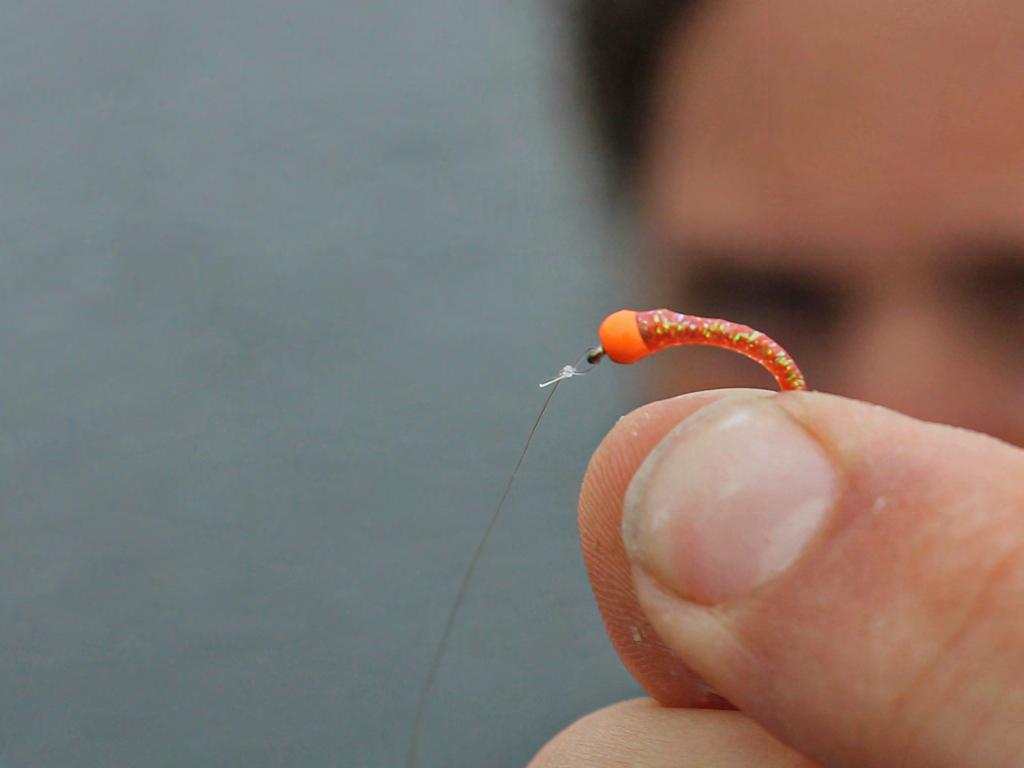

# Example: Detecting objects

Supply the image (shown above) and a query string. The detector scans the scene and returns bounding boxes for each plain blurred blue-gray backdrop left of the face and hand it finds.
[0,0,638,768]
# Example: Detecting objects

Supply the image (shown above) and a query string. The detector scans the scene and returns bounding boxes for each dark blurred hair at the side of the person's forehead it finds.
[570,0,696,187]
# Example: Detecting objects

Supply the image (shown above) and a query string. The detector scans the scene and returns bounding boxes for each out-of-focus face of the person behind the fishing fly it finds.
[638,0,1024,444]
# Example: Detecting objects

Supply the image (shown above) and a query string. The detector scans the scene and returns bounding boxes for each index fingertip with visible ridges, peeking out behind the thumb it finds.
[579,389,771,709]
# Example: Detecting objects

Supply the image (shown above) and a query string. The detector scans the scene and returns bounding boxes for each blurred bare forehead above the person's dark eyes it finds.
[641,0,1024,259]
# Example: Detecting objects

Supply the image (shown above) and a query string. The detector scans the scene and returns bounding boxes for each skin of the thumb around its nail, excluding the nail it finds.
[635,393,1024,768]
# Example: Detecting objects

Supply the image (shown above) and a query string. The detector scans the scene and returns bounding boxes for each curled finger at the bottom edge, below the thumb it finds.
[527,699,813,768]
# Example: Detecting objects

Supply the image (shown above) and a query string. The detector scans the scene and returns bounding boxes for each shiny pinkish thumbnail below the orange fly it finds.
[623,397,837,604]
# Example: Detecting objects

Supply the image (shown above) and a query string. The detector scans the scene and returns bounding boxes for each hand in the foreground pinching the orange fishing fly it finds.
[529,390,1024,768]
